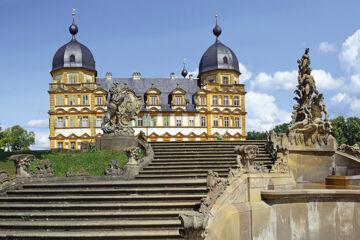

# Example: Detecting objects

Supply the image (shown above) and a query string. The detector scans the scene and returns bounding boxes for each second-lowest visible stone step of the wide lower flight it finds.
[0,219,181,231]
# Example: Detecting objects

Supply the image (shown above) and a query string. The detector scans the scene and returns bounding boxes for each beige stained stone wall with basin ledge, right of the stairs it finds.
[205,174,360,240]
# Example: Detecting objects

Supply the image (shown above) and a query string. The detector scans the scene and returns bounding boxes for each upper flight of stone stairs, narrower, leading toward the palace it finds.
[137,141,273,179]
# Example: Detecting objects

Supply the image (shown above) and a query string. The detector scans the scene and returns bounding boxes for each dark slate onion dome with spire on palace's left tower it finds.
[51,12,96,75]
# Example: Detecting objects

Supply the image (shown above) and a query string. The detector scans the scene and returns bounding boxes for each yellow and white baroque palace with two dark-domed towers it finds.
[48,13,246,149]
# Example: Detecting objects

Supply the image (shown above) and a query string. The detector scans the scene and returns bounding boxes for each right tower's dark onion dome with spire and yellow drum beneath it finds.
[199,11,240,84]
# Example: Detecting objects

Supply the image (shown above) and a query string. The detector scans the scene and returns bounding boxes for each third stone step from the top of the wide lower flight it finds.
[0,194,206,202]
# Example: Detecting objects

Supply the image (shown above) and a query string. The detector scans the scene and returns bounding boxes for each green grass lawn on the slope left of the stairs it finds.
[0,151,127,177]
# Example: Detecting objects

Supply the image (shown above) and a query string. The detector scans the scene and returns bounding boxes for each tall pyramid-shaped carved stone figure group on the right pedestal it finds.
[288,48,331,146]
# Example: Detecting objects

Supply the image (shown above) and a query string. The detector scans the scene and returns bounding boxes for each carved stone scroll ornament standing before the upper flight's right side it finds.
[234,145,259,173]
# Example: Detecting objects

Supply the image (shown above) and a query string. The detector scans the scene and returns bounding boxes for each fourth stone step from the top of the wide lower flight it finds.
[0,200,199,211]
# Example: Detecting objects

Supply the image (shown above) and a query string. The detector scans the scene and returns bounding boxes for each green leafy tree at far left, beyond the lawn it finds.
[0,125,35,151]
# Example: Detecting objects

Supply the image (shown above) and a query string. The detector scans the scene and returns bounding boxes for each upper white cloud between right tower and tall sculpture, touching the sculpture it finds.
[250,70,298,91]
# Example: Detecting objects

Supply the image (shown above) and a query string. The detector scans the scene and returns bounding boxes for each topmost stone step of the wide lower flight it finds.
[23,179,206,189]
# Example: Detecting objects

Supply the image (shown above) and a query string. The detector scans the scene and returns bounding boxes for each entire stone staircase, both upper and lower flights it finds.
[0,141,271,240]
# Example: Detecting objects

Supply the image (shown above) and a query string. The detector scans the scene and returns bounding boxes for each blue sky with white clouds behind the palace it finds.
[0,0,360,148]
